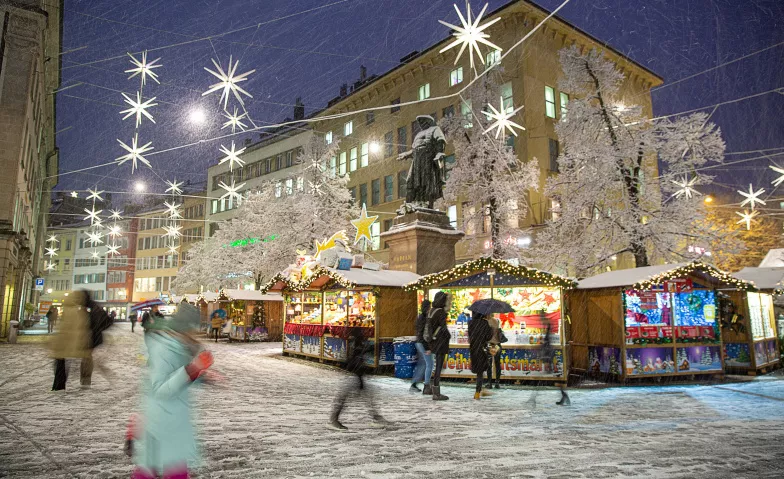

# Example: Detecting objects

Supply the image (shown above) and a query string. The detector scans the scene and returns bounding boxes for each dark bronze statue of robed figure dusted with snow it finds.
[397,115,446,212]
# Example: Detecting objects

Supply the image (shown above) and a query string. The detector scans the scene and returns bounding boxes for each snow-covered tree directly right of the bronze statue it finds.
[441,72,540,258]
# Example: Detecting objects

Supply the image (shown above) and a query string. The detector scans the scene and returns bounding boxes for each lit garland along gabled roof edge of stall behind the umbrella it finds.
[403,256,577,291]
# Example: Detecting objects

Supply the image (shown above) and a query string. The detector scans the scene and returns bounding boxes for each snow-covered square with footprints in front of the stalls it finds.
[0,323,784,479]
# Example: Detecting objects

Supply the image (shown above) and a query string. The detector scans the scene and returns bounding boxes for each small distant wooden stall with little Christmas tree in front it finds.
[217,289,283,341]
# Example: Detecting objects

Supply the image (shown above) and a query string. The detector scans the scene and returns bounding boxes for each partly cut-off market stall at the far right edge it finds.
[719,268,784,374]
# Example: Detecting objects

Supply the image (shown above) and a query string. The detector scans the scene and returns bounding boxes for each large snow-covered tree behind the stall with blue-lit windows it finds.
[529,46,724,275]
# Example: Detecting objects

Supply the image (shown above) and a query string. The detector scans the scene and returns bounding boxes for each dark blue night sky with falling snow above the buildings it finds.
[57,0,784,202]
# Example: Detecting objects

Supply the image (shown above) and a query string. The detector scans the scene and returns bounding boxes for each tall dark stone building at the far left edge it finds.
[0,0,62,337]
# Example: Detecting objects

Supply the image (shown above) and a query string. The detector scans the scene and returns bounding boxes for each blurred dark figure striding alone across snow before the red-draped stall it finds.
[329,326,387,431]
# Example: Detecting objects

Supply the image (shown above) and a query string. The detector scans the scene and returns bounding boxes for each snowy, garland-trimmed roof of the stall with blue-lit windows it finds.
[577,261,754,289]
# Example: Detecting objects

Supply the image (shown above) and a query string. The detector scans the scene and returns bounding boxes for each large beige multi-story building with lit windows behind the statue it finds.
[313,0,662,261]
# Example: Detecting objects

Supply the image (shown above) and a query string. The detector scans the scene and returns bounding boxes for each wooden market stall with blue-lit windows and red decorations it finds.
[568,262,754,380]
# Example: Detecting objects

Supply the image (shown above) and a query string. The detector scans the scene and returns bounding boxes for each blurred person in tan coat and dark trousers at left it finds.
[49,291,92,391]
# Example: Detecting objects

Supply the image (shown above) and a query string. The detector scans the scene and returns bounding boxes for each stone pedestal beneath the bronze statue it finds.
[381,209,464,275]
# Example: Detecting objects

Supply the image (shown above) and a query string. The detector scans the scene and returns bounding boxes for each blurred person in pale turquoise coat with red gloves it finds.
[131,303,213,479]
